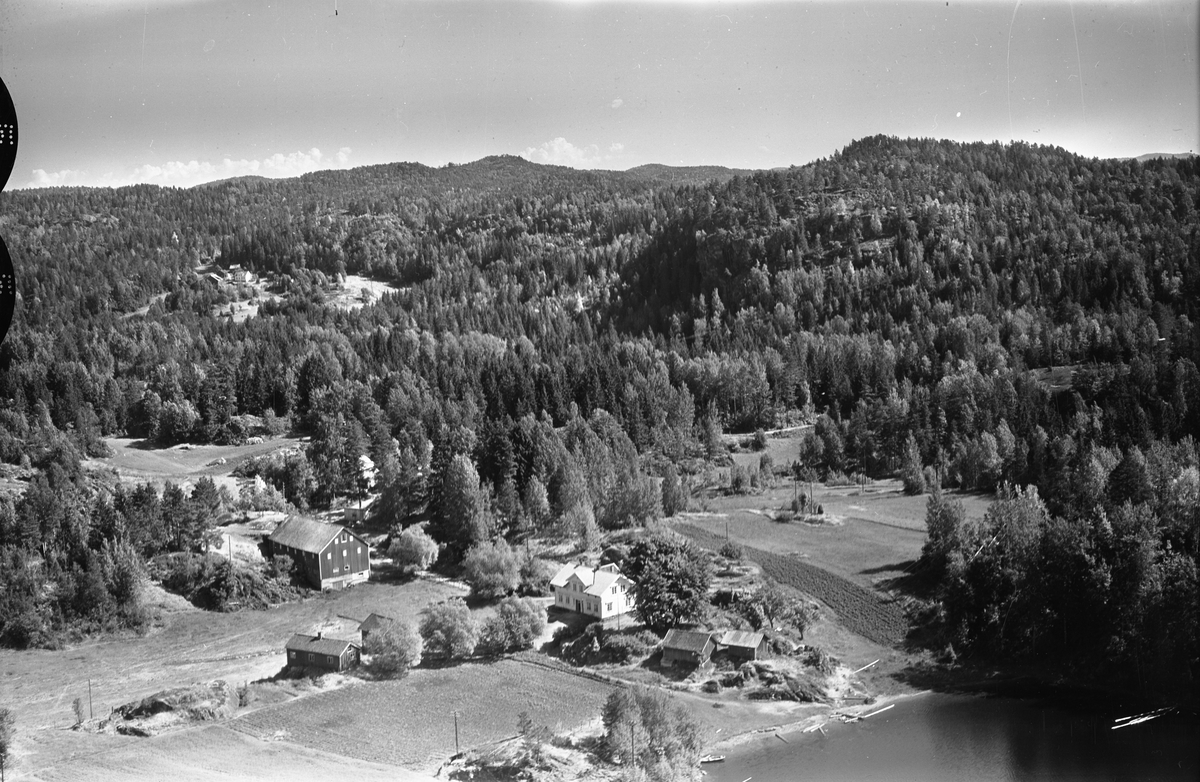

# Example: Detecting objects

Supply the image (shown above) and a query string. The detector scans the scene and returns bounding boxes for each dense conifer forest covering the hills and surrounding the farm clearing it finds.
[0,137,1200,693]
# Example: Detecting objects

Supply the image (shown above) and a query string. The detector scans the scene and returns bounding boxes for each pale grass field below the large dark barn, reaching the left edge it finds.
[0,579,466,778]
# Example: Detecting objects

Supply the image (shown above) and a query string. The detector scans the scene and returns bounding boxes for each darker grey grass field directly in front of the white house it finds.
[230,660,611,770]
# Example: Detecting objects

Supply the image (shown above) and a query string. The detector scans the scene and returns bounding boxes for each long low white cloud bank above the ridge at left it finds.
[23,146,350,187]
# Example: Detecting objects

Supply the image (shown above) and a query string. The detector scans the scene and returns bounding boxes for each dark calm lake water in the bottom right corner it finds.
[703,693,1200,782]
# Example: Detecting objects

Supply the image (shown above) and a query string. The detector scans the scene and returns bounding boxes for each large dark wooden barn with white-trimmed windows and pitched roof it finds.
[269,516,371,589]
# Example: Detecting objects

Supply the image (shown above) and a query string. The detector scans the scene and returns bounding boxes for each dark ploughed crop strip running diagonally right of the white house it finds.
[674,524,908,646]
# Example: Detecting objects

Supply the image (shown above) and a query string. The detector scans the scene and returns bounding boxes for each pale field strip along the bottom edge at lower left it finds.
[25,726,432,782]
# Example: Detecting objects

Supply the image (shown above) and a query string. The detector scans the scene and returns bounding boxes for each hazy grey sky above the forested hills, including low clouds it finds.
[0,0,1200,188]
